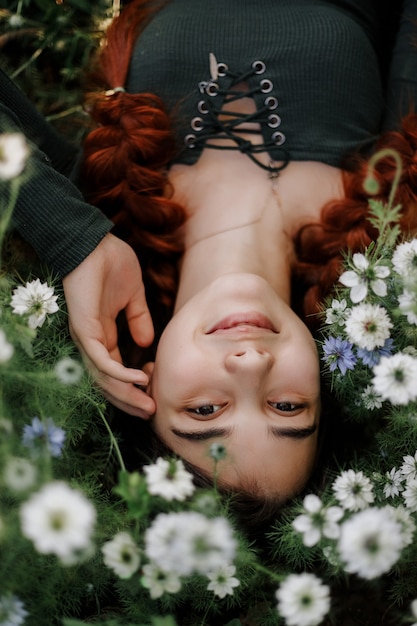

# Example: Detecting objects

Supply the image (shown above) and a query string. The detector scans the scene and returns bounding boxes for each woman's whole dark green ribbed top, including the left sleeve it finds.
[0,0,417,276]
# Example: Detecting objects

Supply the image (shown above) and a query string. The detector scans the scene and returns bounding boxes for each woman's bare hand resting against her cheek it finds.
[63,233,155,418]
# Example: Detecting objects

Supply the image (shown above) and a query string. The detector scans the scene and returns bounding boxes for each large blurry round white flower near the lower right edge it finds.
[338,508,404,579]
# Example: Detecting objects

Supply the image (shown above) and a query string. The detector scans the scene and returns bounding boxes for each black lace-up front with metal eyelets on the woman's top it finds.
[184,54,289,175]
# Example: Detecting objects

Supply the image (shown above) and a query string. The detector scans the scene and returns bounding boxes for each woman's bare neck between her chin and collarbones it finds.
[170,177,293,310]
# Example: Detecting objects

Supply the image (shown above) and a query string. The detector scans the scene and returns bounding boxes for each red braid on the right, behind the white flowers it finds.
[294,114,417,327]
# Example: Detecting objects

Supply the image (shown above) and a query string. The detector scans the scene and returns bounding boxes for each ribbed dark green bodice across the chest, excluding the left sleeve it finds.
[128,0,417,166]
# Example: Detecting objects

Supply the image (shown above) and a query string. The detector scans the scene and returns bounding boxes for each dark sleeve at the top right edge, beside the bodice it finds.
[384,0,417,130]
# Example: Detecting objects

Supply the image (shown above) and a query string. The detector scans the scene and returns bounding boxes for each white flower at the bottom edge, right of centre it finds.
[276,573,330,626]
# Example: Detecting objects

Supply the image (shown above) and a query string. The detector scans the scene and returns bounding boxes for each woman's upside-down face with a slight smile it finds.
[150,274,320,498]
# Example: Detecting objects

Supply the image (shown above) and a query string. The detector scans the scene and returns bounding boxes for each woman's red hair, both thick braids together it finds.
[83,0,417,325]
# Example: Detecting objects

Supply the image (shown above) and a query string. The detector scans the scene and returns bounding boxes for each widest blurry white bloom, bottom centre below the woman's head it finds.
[145,511,236,576]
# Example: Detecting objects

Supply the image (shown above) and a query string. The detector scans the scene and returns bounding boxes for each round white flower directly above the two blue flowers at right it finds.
[345,303,392,350]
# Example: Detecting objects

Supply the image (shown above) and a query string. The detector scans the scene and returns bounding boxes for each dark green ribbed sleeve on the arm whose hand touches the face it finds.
[0,72,113,276]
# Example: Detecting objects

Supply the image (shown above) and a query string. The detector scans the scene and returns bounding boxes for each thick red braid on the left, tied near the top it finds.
[82,0,185,308]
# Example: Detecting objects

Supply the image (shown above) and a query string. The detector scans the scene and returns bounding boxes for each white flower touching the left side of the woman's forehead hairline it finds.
[143,457,195,500]
